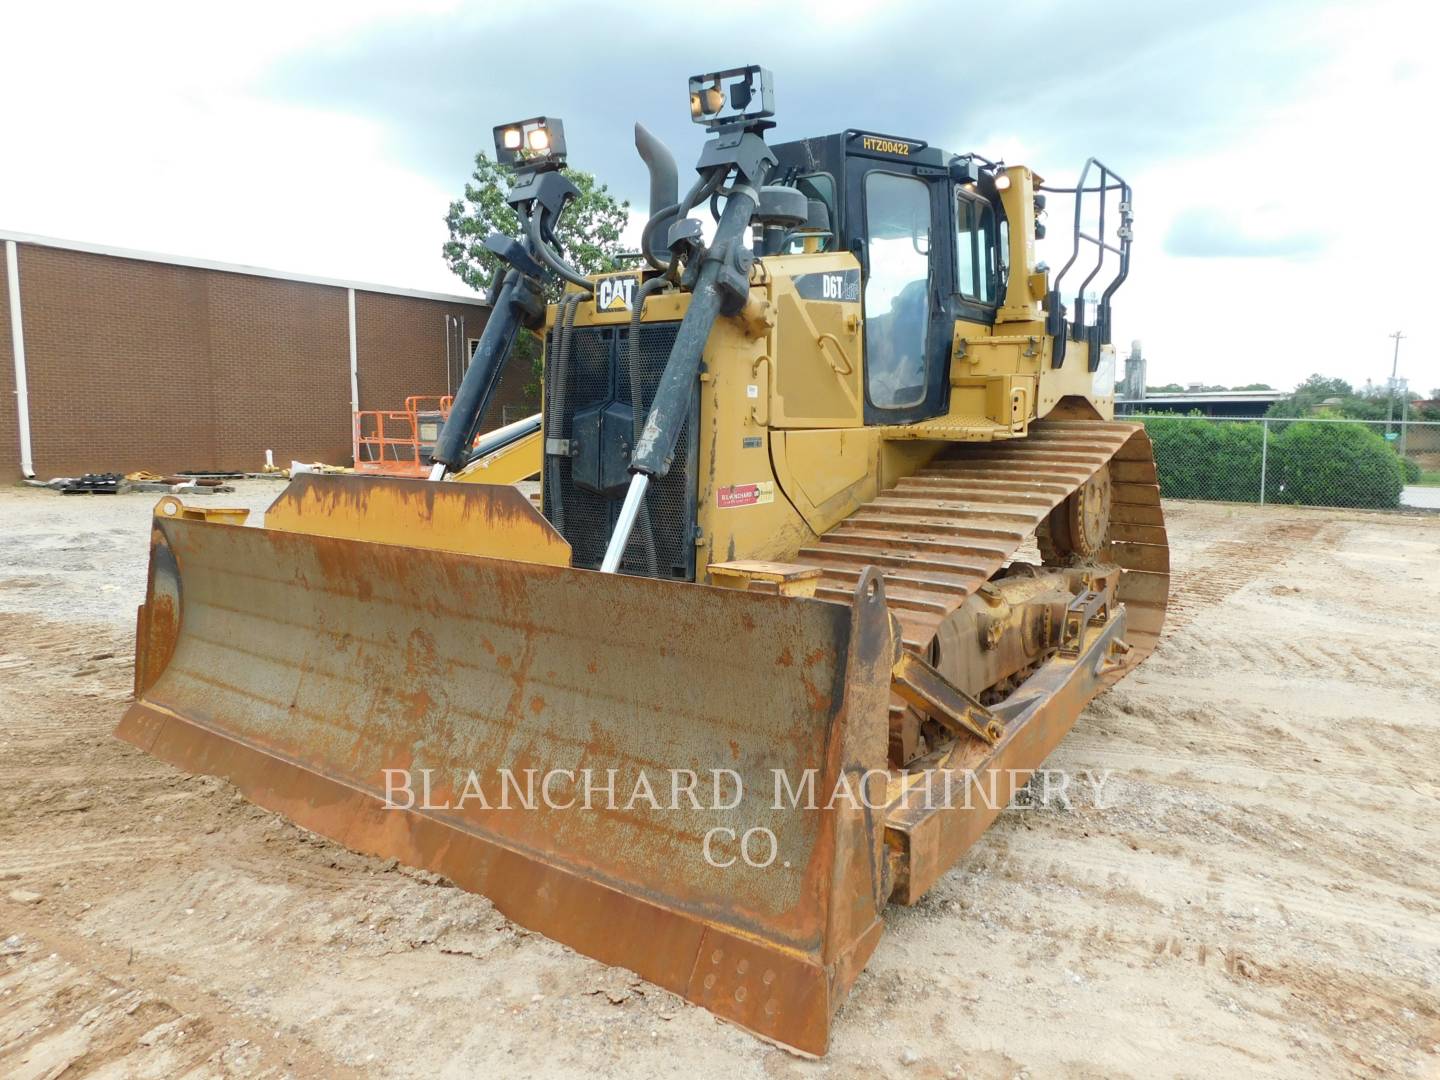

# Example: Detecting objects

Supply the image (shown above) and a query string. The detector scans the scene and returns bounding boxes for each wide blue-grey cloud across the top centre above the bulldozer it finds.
[264,0,1316,202]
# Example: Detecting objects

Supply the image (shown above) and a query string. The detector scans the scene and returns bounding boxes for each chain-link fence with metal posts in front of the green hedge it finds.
[1125,413,1440,510]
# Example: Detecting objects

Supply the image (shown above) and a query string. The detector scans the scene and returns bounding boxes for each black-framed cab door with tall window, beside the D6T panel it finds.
[845,154,955,425]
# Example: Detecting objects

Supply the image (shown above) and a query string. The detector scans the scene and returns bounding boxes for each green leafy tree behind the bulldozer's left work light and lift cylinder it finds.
[444,150,629,408]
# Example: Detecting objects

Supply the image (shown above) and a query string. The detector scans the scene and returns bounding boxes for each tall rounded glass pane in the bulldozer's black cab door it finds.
[864,171,930,409]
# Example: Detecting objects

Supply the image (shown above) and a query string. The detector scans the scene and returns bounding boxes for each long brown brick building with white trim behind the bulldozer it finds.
[0,232,531,482]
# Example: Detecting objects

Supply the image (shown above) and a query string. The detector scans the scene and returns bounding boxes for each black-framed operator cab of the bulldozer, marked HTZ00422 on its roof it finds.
[772,130,1008,423]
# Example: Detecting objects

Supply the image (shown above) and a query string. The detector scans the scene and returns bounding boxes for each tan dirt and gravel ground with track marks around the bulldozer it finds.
[0,481,1440,1080]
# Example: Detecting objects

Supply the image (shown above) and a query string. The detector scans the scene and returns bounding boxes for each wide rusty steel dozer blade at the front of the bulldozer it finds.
[117,477,896,1054]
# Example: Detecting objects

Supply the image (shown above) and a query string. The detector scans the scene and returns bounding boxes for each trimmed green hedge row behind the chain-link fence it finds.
[1139,416,1404,508]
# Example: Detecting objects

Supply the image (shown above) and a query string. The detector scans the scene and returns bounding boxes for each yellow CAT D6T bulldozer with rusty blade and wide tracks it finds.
[117,65,1169,1056]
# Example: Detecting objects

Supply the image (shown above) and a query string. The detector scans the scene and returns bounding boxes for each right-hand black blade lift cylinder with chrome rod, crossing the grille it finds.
[600,184,759,573]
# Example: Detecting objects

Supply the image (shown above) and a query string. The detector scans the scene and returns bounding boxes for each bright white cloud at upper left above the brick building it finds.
[0,0,467,292]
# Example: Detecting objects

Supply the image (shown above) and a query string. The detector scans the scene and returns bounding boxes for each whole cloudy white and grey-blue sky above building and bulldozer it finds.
[0,0,1440,393]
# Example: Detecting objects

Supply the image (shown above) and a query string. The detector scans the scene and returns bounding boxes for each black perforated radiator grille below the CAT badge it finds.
[543,323,698,580]
